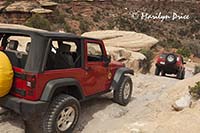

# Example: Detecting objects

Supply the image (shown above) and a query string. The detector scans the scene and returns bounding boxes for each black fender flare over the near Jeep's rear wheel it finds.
[40,78,85,101]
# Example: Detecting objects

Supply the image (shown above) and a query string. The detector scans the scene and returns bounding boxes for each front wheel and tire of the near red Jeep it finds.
[114,76,133,106]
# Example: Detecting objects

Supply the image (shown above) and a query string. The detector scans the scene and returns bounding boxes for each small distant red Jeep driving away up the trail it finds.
[155,53,185,79]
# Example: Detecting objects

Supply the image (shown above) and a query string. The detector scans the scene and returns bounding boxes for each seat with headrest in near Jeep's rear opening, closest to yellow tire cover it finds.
[5,40,20,67]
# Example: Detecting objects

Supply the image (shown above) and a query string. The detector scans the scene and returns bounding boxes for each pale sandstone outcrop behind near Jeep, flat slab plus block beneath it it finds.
[82,30,158,71]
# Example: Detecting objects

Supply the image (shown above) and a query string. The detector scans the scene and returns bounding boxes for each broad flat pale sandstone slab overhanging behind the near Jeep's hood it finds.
[82,30,158,50]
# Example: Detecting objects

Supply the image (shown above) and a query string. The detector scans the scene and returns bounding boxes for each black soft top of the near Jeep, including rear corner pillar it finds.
[0,24,98,73]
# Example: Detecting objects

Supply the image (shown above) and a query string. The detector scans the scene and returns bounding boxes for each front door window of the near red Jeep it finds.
[87,42,103,62]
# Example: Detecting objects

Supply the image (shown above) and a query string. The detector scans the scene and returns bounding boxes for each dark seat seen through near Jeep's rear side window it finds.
[55,44,74,69]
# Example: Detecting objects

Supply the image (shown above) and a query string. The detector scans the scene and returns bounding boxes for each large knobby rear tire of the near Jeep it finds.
[43,94,80,133]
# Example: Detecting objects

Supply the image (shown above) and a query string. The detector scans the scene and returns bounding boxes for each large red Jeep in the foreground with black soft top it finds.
[0,25,133,133]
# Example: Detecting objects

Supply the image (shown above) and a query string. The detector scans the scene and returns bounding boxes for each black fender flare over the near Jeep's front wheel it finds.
[110,67,134,90]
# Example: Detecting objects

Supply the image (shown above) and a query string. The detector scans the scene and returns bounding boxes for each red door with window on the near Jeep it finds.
[84,39,109,95]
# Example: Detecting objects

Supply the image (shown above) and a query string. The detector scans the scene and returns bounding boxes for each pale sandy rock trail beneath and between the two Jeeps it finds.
[0,68,192,133]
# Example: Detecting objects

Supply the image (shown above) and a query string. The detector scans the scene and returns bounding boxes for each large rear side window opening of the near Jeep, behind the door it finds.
[46,40,81,70]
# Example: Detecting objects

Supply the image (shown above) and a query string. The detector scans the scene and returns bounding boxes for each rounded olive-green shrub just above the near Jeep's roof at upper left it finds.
[25,14,51,30]
